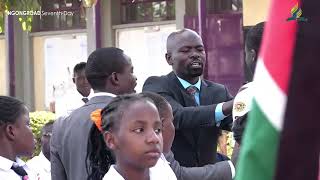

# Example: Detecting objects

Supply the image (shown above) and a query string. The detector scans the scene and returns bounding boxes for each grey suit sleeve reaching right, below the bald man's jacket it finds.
[165,152,232,180]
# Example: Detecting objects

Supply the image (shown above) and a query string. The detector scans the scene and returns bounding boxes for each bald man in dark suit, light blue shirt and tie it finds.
[143,29,233,167]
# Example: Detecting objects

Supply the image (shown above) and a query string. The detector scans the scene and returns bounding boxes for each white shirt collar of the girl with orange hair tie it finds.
[103,154,177,180]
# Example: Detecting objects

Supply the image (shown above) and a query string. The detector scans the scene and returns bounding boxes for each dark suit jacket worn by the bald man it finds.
[143,72,232,167]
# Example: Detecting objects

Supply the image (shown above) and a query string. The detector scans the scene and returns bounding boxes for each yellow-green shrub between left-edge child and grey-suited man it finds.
[29,111,56,156]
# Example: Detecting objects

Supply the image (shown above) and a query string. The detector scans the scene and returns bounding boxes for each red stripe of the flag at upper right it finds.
[259,0,298,94]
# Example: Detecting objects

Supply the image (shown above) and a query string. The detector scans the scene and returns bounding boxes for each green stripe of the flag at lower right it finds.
[236,99,279,180]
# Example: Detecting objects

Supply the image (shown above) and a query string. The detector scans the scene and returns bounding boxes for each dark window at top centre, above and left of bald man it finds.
[121,0,175,24]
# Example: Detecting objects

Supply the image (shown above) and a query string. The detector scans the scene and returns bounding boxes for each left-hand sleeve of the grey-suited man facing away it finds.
[50,117,67,180]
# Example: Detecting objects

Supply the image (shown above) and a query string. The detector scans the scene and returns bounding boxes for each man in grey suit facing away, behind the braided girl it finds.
[51,48,136,180]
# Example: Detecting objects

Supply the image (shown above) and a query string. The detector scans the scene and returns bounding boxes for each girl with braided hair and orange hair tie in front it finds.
[87,95,176,180]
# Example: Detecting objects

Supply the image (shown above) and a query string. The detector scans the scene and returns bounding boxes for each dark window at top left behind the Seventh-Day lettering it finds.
[32,0,86,32]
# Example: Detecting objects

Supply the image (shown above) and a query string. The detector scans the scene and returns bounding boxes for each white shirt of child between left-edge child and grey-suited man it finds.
[27,151,51,180]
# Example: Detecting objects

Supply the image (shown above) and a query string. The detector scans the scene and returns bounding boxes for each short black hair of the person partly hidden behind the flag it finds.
[245,22,264,53]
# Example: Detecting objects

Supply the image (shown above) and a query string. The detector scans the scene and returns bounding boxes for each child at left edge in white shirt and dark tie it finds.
[0,96,38,180]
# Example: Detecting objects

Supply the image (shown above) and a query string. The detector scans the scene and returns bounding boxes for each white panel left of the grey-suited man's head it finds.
[44,34,88,107]
